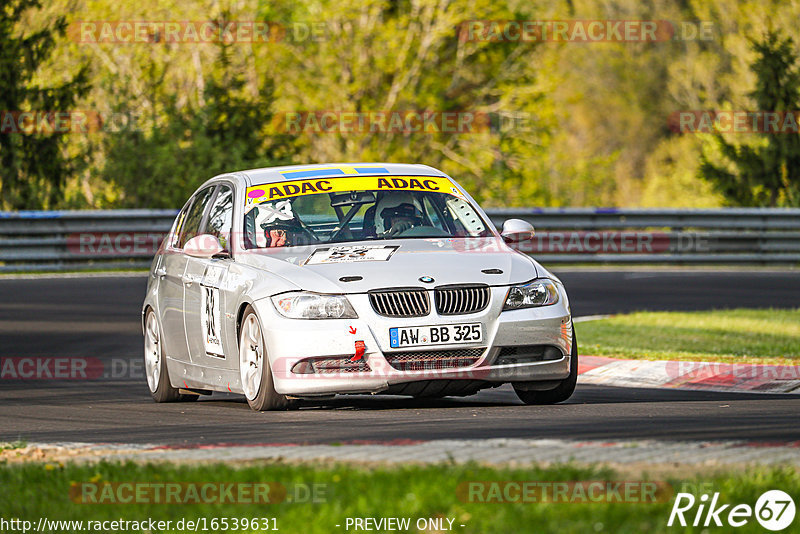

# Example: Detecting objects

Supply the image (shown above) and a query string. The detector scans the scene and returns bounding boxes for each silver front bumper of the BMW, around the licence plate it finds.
[255,285,572,396]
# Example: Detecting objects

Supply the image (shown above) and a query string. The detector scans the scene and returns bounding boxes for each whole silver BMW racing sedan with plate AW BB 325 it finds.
[142,163,578,410]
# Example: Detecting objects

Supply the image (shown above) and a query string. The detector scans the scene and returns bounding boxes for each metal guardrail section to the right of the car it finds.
[487,208,800,264]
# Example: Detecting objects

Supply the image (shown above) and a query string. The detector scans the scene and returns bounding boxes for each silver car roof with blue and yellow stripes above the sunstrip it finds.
[240,163,447,185]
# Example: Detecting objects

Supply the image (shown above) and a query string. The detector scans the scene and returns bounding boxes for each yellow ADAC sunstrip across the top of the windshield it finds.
[246,175,462,209]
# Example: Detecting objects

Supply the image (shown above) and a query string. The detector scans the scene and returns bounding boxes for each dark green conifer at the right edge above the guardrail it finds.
[699,31,800,207]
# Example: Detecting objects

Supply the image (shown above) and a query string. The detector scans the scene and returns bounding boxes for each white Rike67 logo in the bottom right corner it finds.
[667,490,795,532]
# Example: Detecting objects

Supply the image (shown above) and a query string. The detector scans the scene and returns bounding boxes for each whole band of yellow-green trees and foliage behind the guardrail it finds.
[7,0,800,208]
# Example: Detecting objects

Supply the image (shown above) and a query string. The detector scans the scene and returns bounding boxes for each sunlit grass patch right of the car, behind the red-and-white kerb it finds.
[575,309,800,365]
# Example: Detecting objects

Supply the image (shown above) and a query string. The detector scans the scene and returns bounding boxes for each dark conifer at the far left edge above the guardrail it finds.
[0,0,89,209]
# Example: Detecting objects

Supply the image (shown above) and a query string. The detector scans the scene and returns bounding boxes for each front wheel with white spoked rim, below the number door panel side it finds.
[239,306,291,412]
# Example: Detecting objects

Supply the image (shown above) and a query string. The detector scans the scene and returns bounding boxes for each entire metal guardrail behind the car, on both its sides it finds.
[0,208,800,272]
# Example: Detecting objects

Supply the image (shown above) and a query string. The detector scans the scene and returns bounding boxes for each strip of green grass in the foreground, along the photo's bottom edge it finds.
[0,463,800,534]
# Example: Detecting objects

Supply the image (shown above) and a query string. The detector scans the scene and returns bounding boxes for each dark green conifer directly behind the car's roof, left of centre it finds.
[102,41,289,208]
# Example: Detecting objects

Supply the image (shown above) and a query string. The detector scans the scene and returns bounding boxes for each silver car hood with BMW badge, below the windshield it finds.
[237,237,537,296]
